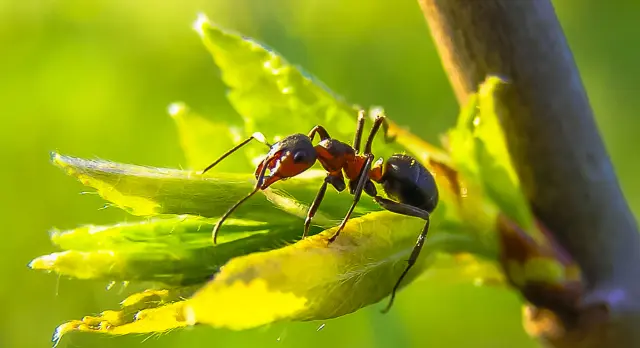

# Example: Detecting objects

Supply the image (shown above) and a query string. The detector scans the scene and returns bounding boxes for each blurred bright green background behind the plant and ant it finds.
[0,0,640,348]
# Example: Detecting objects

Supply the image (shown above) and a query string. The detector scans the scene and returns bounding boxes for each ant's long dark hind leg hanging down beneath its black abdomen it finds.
[374,196,431,313]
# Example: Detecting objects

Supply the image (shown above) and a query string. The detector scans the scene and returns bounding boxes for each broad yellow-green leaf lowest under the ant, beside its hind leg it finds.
[188,212,444,328]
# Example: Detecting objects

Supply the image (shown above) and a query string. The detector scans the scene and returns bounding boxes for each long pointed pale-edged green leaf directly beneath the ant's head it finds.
[52,153,380,223]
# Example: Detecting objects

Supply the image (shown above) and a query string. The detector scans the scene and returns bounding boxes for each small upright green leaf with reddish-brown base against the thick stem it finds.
[450,76,584,312]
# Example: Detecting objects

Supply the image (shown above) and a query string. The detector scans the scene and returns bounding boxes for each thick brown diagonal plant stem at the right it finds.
[419,0,640,347]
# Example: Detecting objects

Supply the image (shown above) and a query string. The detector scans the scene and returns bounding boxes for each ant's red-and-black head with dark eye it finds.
[255,134,318,190]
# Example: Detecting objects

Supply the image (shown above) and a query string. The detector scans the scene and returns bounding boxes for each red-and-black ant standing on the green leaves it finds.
[202,110,438,313]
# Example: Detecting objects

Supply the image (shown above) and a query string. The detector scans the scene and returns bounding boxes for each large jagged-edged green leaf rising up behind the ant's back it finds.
[194,14,401,163]
